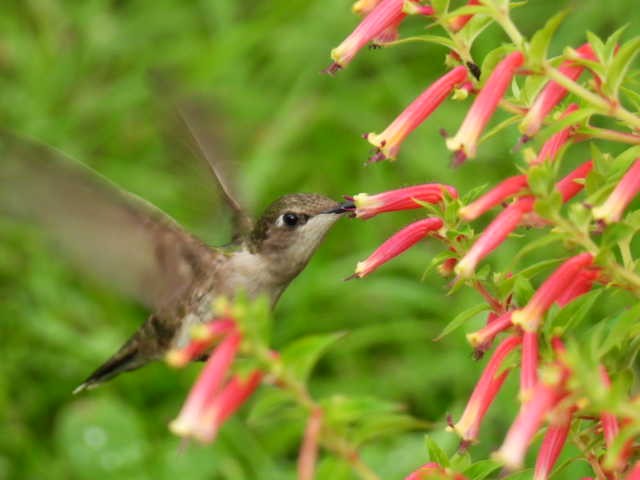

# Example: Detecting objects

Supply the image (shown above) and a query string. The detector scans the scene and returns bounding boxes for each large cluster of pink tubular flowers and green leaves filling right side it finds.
[330,0,640,480]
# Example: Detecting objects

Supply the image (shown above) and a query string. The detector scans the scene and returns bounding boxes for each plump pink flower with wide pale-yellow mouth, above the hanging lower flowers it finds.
[512,253,593,332]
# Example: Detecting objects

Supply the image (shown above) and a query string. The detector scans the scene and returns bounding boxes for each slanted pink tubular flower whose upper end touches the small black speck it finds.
[365,66,467,161]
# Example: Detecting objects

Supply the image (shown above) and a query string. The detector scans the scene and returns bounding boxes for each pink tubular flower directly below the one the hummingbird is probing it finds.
[349,217,444,278]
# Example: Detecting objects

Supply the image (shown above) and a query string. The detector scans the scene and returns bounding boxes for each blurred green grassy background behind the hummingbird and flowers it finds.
[0,0,640,480]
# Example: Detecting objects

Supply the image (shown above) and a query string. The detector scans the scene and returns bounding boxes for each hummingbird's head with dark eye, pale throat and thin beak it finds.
[249,193,349,280]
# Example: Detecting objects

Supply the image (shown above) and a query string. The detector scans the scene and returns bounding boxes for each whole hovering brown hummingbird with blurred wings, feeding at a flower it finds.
[0,115,349,393]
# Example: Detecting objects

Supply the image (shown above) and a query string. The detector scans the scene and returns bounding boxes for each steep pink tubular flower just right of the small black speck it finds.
[447,52,524,164]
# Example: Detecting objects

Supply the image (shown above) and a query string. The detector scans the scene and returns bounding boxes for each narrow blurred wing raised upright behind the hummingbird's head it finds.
[176,101,253,241]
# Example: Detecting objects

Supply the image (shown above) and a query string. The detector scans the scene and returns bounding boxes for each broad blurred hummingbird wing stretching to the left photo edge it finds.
[0,131,217,310]
